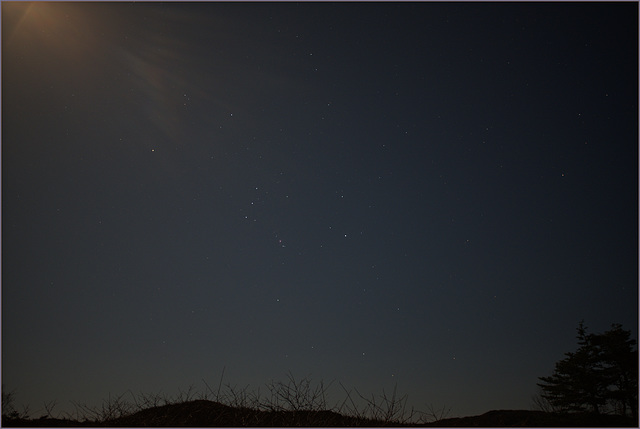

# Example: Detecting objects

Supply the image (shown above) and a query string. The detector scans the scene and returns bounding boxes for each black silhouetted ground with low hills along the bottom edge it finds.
[2,400,638,427]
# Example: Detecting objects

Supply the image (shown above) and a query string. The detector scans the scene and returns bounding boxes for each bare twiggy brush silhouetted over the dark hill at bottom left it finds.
[2,370,448,427]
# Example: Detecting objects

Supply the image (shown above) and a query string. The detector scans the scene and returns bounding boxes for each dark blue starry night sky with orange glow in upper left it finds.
[2,2,638,417]
